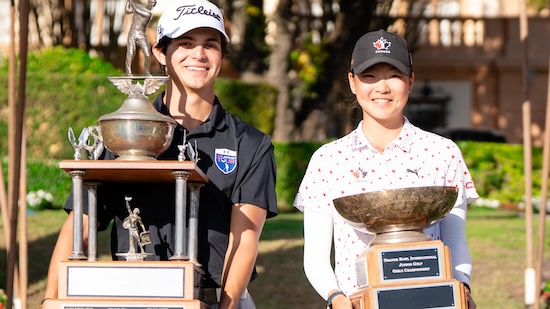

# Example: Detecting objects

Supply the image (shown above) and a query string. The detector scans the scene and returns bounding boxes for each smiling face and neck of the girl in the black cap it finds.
[348,63,414,123]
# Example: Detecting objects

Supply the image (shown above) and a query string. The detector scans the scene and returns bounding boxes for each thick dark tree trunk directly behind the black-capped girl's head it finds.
[292,0,383,141]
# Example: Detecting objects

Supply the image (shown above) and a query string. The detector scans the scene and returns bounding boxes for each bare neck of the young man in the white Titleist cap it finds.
[164,85,215,131]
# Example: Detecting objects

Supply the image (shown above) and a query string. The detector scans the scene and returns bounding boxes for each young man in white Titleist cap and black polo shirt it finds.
[45,0,277,309]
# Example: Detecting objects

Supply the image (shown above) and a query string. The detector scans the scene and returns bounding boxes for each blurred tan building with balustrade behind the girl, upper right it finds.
[390,0,550,146]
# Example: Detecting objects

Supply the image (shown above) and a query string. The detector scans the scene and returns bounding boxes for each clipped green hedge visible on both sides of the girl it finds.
[275,141,542,211]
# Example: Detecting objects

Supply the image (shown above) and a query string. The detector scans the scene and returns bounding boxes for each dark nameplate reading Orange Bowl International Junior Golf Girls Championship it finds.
[379,246,442,282]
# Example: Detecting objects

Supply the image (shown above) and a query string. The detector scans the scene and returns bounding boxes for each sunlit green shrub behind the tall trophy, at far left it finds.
[0,47,124,159]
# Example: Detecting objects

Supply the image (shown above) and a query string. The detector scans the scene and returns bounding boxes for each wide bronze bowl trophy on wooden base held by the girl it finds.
[334,187,468,309]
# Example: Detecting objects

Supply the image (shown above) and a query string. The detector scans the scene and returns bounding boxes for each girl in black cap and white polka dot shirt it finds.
[294,30,479,309]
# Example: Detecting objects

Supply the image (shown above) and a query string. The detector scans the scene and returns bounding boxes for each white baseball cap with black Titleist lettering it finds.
[157,0,229,44]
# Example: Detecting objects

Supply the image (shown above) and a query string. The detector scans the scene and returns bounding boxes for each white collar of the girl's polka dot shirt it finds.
[350,116,417,152]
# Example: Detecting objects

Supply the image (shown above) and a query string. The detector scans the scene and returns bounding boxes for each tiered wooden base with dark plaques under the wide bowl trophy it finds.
[350,240,468,309]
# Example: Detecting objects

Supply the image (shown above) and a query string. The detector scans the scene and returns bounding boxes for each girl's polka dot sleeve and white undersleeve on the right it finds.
[440,145,479,285]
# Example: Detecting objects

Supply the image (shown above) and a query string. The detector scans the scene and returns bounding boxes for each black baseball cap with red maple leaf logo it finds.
[350,30,412,76]
